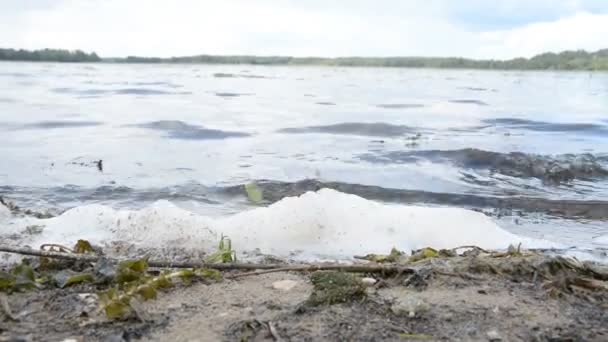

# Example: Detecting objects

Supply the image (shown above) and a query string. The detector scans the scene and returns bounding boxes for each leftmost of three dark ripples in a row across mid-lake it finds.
[132,120,251,140]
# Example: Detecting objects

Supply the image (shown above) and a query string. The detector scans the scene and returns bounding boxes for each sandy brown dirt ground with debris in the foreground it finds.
[0,252,608,341]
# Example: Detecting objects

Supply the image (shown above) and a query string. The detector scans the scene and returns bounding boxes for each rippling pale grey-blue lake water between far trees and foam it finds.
[0,63,608,256]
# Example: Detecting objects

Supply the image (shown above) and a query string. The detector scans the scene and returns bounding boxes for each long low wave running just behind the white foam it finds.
[7,179,608,220]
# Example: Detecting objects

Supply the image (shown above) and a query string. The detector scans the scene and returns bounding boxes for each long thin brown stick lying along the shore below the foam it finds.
[0,245,415,278]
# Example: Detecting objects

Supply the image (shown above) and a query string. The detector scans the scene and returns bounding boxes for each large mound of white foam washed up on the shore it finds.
[4,189,555,258]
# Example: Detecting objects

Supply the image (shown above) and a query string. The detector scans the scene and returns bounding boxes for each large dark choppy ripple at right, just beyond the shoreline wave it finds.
[359,148,608,183]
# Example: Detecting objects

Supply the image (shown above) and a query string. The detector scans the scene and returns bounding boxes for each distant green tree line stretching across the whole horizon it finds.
[0,49,608,70]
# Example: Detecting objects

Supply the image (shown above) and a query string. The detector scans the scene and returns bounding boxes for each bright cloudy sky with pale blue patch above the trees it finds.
[0,0,608,58]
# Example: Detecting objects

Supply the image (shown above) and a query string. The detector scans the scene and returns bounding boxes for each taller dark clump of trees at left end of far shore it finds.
[0,49,101,62]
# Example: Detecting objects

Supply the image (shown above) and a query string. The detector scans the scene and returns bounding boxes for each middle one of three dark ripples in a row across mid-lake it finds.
[279,122,415,137]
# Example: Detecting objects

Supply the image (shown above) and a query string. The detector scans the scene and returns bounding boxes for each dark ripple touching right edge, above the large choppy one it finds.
[483,118,608,133]
